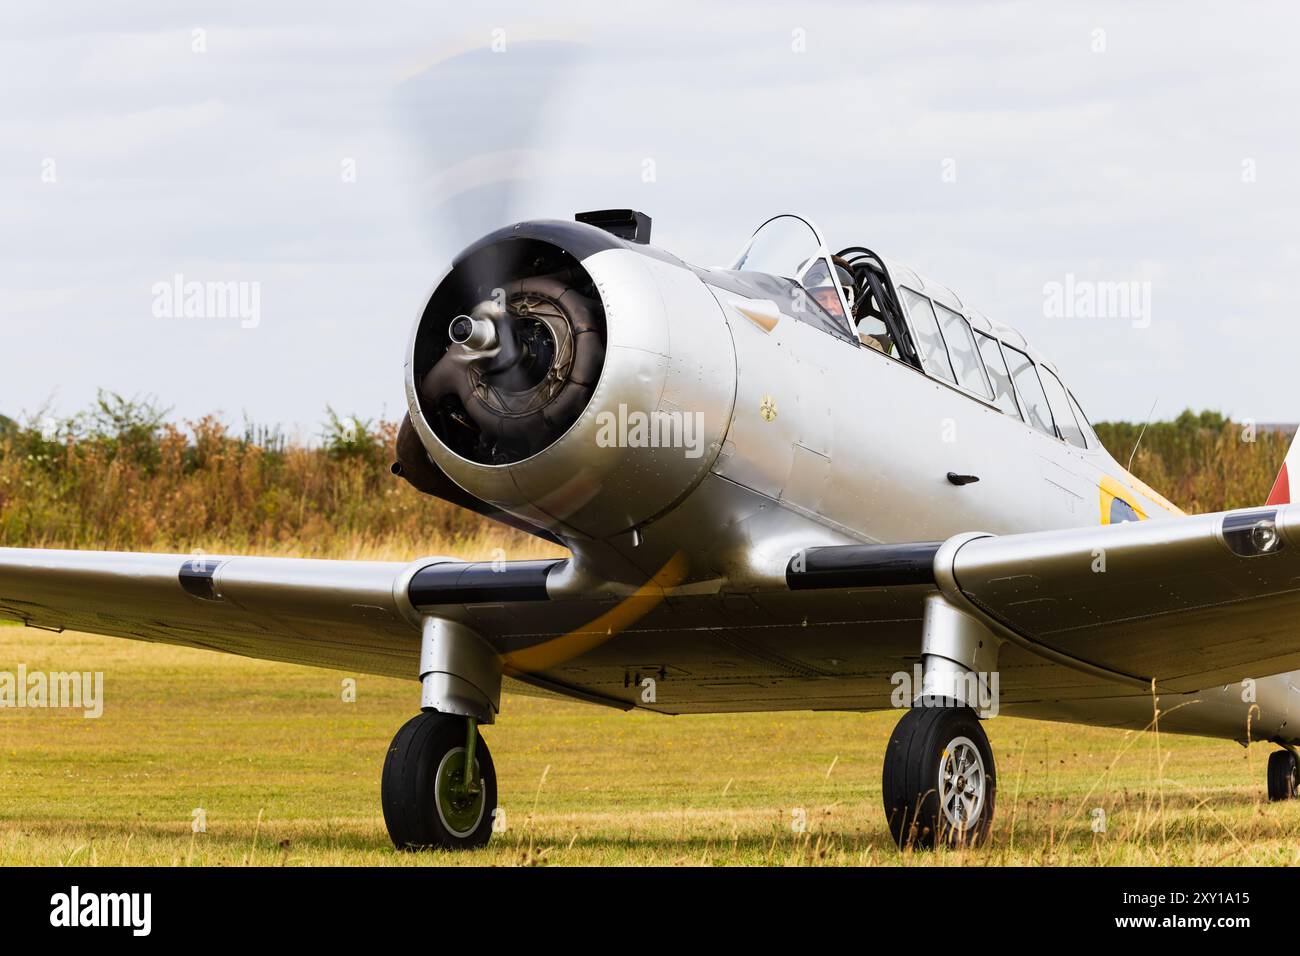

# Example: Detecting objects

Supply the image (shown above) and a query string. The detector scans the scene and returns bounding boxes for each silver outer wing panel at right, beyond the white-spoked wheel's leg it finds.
[935,506,1300,692]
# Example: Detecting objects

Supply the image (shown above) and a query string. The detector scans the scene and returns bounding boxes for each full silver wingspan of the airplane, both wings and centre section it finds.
[10,505,1300,713]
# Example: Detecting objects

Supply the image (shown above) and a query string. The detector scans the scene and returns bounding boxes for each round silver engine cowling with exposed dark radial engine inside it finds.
[406,221,736,538]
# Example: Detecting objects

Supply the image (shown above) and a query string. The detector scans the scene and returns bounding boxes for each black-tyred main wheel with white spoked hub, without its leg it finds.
[883,704,997,848]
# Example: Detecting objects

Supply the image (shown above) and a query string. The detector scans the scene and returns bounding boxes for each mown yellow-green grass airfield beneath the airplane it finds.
[0,623,1300,866]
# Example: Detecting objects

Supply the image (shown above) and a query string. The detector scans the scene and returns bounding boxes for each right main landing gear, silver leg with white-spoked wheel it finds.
[881,594,1000,849]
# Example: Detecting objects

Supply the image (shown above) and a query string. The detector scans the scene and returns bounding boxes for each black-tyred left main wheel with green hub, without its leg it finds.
[381,711,497,849]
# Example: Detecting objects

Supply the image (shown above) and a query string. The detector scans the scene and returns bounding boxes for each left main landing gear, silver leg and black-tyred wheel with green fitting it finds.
[381,618,501,849]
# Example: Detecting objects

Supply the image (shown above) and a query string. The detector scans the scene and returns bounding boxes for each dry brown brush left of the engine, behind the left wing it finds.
[0,395,559,558]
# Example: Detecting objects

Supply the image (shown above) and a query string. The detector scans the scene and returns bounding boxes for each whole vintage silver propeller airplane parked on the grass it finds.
[0,211,1300,848]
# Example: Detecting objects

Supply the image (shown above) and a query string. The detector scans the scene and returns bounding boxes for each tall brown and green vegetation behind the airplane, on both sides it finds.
[0,393,1287,558]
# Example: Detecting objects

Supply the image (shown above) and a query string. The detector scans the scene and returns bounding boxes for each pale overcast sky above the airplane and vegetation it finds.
[0,0,1300,429]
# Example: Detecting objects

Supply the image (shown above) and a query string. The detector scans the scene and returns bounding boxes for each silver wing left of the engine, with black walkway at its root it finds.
[0,548,556,680]
